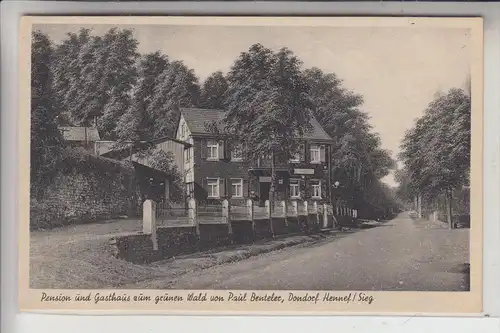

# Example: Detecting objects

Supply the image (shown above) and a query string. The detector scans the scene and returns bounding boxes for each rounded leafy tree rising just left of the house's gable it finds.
[147,61,200,138]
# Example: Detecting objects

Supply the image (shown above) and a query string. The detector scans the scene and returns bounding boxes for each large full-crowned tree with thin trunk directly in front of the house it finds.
[212,44,312,233]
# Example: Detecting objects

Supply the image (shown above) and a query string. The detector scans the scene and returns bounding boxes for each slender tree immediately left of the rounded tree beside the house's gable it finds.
[117,52,169,141]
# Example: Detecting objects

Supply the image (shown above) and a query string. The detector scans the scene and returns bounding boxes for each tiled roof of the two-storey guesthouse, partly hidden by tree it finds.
[180,108,333,141]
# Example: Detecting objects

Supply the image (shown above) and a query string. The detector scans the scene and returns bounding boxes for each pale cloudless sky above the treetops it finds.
[34,24,471,185]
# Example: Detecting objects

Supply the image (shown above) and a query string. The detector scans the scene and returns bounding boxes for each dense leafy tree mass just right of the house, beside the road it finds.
[304,68,395,210]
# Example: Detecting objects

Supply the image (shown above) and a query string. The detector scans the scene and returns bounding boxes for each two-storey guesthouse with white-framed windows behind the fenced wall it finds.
[176,108,333,204]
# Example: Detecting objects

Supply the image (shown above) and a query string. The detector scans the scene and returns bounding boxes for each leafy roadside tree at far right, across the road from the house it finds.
[400,88,471,227]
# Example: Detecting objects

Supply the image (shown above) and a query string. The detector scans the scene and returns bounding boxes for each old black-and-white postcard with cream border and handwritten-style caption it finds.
[19,16,483,315]
